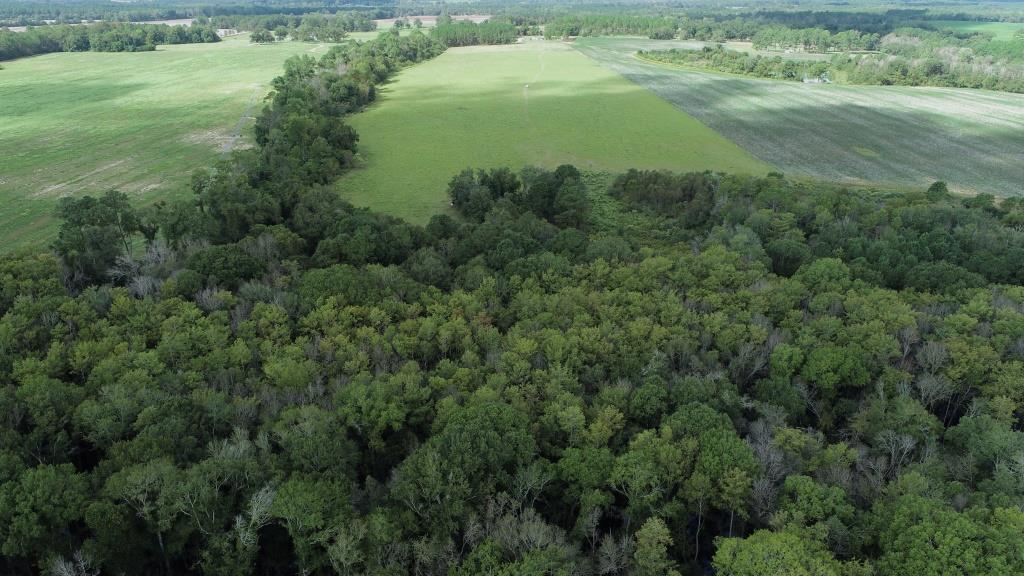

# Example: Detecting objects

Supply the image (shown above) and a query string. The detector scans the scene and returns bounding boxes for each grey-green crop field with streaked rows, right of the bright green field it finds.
[574,38,1024,196]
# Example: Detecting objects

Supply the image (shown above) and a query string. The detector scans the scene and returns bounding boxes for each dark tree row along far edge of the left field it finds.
[0,23,220,60]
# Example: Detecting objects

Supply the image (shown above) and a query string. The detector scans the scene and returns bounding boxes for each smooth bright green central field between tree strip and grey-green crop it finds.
[338,40,769,222]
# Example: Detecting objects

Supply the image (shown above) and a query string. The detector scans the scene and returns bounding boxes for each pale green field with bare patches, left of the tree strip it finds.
[0,35,326,251]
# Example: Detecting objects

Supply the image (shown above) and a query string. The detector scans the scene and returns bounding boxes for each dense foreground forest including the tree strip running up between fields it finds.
[12,7,1024,576]
